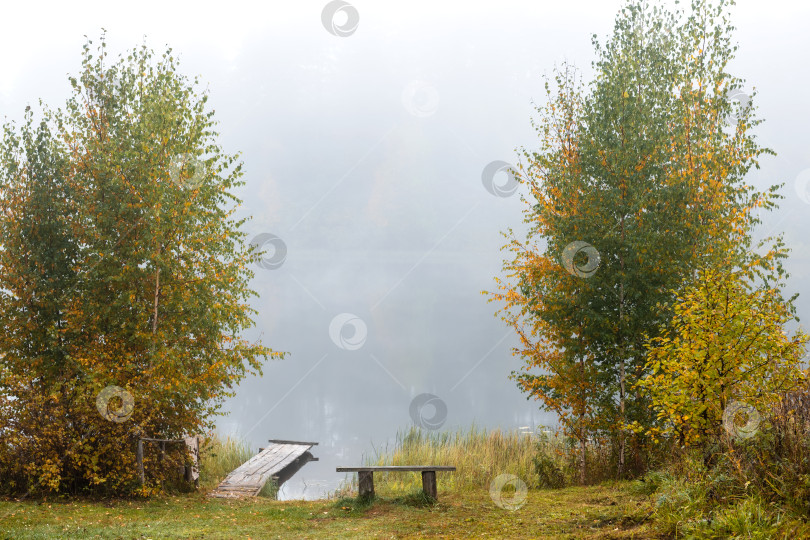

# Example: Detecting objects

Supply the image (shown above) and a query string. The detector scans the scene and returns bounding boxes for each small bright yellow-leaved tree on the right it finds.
[637,269,809,445]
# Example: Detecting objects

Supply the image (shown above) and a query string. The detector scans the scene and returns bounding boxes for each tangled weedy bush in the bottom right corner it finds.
[648,391,810,538]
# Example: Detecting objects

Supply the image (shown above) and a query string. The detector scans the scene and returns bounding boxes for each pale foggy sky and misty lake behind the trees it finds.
[0,0,810,497]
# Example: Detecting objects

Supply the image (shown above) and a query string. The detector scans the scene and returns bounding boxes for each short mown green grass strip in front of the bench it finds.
[0,483,655,539]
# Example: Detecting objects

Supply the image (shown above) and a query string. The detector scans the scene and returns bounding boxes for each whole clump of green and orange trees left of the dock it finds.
[0,35,280,494]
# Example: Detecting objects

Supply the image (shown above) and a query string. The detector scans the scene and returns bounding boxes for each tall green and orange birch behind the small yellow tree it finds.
[493,0,775,476]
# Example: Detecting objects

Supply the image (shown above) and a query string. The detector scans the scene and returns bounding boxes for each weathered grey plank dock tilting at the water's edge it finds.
[209,439,318,499]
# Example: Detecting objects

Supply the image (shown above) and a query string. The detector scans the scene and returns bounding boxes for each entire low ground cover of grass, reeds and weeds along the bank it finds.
[0,424,810,539]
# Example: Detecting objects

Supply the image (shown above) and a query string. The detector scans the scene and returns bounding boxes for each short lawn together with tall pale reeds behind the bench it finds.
[0,428,654,539]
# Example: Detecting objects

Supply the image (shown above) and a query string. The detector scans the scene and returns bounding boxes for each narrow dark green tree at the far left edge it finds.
[0,108,80,490]
